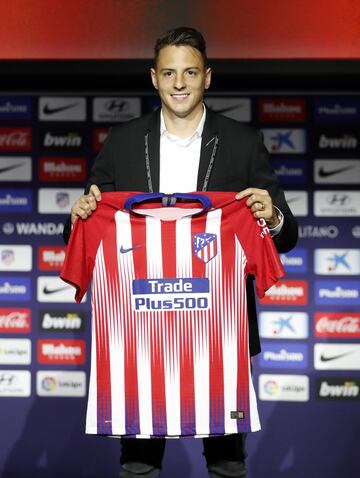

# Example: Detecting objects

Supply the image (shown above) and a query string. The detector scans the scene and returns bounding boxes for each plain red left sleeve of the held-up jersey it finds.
[60,195,114,303]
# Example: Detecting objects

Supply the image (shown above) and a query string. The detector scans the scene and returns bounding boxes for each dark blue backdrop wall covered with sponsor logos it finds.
[0,92,360,478]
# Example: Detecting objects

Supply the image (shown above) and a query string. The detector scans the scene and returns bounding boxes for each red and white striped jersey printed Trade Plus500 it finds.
[61,192,283,437]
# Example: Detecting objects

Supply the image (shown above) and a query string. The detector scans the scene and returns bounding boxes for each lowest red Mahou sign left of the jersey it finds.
[38,339,85,364]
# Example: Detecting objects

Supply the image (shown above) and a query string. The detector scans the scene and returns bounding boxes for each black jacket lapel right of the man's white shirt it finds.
[197,108,218,191]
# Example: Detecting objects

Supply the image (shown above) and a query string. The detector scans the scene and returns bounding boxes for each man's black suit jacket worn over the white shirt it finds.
[64,109,298,355]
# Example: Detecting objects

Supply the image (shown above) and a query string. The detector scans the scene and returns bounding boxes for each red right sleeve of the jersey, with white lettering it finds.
[225,198,285,298]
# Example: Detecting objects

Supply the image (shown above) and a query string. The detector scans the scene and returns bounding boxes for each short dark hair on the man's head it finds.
[154,27,207,66]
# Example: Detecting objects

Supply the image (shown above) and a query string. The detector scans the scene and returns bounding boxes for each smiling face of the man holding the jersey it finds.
[151,45,211,119]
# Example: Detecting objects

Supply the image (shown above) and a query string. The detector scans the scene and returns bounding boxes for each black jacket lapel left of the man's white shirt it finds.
[145,108,160,192]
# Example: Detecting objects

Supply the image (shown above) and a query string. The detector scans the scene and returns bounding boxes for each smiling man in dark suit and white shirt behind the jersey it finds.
[64,28,297,478]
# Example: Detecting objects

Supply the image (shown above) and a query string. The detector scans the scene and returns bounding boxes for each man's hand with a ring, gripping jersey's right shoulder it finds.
[235,188,280,229]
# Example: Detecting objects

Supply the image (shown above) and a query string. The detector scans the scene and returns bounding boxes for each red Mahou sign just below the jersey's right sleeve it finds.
[260,280,308,305]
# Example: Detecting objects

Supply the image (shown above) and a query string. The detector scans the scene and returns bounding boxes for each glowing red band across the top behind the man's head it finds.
[0,0,360,59]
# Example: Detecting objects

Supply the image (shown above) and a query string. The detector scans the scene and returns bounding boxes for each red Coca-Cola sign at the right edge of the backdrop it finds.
[315,312,360,339]
